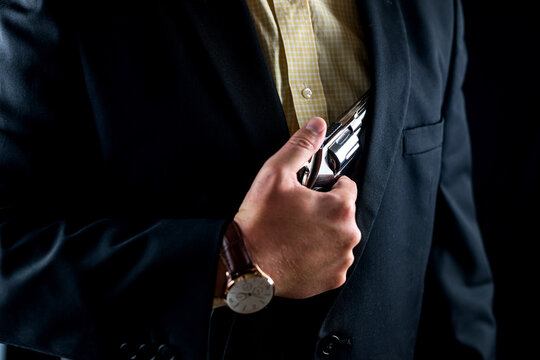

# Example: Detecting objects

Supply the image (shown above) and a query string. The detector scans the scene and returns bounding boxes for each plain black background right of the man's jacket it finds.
[462,0,540,360]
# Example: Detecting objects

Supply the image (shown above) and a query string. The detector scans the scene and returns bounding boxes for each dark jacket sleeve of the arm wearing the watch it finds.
[0,0,226,359]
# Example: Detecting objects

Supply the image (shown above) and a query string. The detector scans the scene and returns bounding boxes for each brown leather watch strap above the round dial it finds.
[221,221,255,278]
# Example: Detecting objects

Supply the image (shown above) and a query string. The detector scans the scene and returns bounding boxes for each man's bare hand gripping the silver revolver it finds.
[235,118,360,299]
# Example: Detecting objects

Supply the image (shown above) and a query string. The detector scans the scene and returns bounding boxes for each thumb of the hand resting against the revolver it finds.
[272,117,326,173]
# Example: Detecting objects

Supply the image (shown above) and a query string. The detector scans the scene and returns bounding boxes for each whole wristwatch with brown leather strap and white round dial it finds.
[220,221,274,314]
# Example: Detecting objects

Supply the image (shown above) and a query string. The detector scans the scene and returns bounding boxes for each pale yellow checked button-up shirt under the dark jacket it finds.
[247,0,369,134]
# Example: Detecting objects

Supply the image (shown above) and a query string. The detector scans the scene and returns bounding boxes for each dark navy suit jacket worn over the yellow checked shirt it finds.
[0,0,495,359]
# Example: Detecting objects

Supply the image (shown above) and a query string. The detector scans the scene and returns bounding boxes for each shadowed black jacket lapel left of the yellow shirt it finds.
[184,0,289,161]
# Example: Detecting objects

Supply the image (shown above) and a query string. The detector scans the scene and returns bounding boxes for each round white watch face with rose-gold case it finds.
[226,274,274,314]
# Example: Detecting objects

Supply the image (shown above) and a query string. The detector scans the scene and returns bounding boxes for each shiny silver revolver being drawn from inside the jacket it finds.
[297,90,370,191]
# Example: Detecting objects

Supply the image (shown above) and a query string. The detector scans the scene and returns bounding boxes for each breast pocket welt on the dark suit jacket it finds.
[403,118,444,156]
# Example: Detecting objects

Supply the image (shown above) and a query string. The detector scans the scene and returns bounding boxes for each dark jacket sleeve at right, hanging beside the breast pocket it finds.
[416,1,496,359]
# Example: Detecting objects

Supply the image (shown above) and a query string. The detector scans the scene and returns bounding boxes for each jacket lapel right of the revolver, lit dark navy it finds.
[355,0,410,259]
